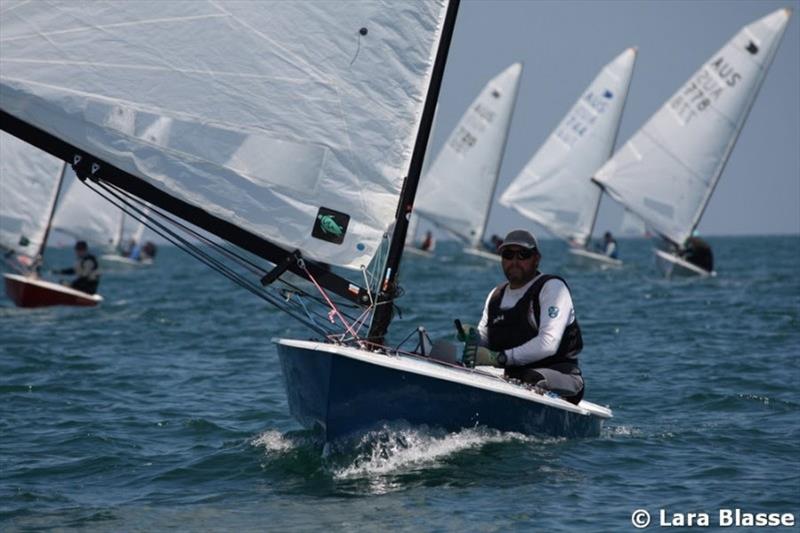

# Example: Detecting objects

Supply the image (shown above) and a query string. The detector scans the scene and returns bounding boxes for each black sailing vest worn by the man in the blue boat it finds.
[487,274,583,368]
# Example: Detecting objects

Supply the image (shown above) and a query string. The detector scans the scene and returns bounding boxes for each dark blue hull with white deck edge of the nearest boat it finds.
[278,340,611,440]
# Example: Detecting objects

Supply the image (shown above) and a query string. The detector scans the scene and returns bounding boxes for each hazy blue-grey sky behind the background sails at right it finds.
[420,0,800,238]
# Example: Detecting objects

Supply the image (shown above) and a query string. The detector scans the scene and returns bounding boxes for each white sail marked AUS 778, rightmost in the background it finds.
[594,9,790,245]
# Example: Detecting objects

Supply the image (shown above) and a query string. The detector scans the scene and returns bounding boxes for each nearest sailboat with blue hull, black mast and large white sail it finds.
[0,0,611,440]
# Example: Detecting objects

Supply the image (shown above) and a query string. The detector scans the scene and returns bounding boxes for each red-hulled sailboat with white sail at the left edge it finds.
[0,132,103,307]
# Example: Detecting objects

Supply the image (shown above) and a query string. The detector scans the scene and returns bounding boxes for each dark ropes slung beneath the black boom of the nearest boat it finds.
[89,183,344,335]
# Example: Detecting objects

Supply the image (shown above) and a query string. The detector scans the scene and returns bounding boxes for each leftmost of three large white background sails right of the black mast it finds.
[414,63,522,246]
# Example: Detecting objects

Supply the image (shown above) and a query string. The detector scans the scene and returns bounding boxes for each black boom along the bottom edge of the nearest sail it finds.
[0,109,369,305]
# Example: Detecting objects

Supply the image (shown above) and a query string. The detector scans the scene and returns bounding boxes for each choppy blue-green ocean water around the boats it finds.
[0,236,800,531]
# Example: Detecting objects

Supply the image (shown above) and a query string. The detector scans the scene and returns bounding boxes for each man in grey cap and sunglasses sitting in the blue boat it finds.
[476,230,583,403]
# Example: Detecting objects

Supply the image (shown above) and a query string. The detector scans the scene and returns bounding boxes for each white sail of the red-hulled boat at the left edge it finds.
[0,132,64,260]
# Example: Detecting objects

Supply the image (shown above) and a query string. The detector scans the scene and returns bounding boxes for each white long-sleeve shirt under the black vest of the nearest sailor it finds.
[478,274,575,366]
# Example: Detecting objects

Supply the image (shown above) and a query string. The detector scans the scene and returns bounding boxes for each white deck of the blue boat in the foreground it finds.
[272,339,613,418]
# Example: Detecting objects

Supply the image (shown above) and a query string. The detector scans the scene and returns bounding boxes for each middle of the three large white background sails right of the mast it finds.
[500,48,636,246]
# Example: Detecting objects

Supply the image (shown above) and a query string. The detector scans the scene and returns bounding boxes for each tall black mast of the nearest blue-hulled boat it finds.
[368,0,460,344]
